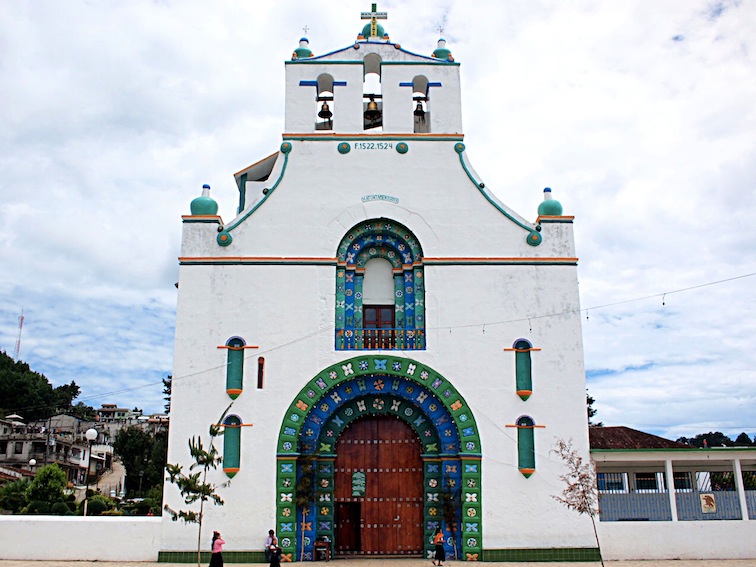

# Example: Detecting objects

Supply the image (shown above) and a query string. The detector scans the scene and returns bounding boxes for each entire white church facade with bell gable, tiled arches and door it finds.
[160,6,598,561]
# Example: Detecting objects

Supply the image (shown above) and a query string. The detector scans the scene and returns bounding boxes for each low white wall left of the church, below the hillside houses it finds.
[0,516,159,561]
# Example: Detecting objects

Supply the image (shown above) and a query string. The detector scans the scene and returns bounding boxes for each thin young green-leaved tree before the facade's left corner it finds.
[164,405,231,567]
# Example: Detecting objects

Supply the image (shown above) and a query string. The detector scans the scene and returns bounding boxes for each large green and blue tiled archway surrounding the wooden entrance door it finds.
[276,355,483,561]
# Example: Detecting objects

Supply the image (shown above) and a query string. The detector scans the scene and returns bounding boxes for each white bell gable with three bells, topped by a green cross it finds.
[285,4,462,134]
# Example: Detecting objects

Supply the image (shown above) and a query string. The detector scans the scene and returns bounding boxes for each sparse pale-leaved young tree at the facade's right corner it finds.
[551,439,604,567]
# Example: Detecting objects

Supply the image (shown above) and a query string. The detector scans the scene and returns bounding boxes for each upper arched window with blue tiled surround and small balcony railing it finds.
[336,219,425,350]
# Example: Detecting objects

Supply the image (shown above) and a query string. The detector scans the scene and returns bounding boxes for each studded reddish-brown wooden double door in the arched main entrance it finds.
[334,416,424,556]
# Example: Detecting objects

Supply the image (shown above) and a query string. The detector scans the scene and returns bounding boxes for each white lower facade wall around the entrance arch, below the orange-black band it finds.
[163,260,591,550]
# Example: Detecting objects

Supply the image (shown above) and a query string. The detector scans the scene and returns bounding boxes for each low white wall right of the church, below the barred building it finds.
[596,520,756,561]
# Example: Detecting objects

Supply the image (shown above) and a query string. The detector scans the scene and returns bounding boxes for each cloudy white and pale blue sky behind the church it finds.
[0,0,756,439]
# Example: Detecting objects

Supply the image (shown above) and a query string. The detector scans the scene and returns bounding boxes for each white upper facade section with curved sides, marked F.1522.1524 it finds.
[198,140,548,258]
